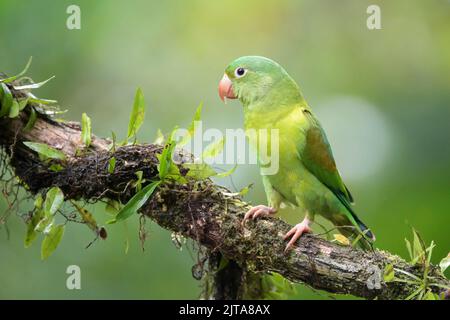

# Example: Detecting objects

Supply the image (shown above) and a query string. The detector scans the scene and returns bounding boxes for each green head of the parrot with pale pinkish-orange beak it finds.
[219,56,300,106]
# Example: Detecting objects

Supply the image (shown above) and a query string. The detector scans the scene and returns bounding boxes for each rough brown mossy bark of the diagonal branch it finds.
[0,85,450,299]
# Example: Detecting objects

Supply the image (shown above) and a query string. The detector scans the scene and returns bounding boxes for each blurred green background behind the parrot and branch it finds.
[0,0,450,299]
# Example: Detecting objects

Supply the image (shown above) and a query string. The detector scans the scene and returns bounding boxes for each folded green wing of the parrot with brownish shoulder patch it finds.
[298,108,353,206]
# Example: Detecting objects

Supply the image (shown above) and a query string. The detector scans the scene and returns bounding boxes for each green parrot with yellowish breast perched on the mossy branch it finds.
[219,56,375,250]
